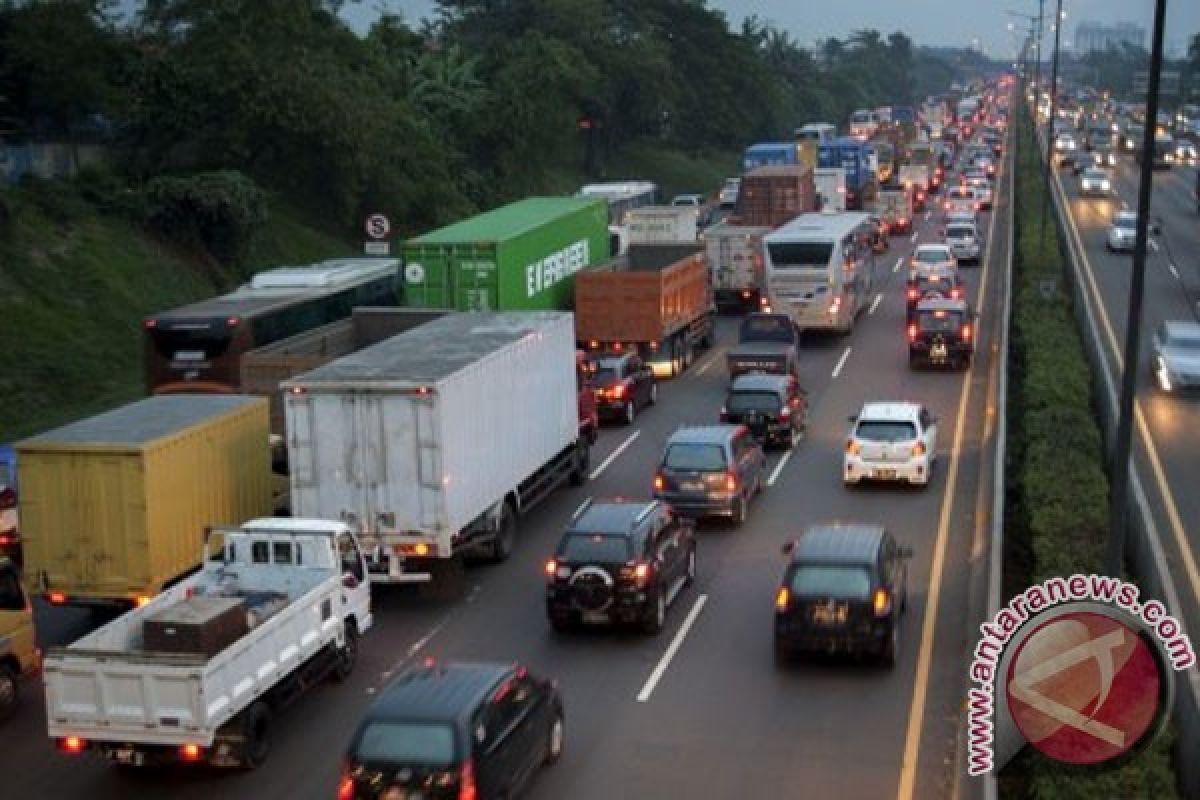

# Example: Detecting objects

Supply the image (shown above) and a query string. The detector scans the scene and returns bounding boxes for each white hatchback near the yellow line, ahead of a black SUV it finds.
[842,403,937,486]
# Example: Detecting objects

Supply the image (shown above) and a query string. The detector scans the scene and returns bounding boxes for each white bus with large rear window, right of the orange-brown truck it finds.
[762,211,876,333]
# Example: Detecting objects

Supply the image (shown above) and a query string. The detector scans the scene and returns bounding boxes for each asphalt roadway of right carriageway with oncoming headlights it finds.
[1058,148,1200,632]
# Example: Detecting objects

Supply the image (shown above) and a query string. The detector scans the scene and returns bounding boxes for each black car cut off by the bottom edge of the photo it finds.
[337,661,564,800]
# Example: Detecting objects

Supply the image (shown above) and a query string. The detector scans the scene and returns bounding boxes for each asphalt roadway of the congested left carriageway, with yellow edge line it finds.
[0,163,1012,800]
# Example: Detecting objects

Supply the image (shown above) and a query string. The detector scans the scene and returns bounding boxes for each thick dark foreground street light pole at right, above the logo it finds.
[1105,0,1166,577]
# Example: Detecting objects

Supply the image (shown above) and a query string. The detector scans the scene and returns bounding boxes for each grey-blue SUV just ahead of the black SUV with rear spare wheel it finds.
[654,425,767,525]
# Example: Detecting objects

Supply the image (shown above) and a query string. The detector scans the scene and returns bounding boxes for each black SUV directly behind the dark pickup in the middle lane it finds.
[721,374,808,447]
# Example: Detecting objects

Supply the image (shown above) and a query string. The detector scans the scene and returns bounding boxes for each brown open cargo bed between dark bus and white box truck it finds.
[241,307,451,437]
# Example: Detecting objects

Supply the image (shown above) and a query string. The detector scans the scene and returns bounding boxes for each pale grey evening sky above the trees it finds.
[344,0,1200,58]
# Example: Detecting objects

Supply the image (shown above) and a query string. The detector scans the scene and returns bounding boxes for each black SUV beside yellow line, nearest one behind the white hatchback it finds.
[775,524,912,667]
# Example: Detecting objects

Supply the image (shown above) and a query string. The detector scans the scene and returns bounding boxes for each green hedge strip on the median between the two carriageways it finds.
[1001,106,1178,800]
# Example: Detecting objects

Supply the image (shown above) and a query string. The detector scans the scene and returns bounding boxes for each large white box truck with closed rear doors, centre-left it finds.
[283,312,589,596]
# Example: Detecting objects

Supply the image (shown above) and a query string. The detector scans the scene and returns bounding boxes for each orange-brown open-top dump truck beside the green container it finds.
[575,243,715,377]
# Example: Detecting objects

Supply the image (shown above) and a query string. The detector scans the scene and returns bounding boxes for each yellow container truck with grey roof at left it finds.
[17,395,271,607]
